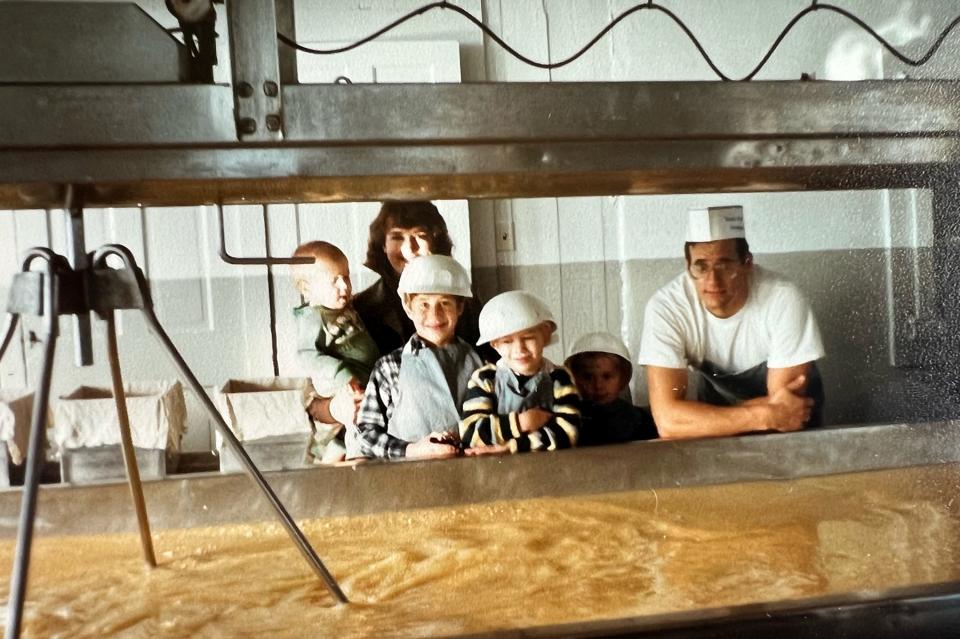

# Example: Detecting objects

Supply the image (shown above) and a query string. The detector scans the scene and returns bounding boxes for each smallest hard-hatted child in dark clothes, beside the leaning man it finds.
[566,333,657,446]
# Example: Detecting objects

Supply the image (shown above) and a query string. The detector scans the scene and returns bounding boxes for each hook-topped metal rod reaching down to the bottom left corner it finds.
[5,255,59,639]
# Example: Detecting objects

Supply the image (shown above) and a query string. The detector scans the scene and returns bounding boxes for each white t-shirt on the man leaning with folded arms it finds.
[639,266,824,374]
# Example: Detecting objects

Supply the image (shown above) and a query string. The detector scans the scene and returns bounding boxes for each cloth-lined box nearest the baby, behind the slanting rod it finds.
[214,377,313,472]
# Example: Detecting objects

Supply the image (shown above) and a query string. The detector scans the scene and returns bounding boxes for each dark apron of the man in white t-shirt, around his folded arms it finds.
[697,362,824,428]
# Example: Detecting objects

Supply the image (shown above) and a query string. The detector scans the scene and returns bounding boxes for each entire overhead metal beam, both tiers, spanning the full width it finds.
[0,81,960,208]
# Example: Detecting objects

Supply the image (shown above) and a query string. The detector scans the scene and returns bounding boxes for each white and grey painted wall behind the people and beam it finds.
[0,0,960,450]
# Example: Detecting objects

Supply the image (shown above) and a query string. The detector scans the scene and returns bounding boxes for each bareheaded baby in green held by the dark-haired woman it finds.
[291,241,380,462]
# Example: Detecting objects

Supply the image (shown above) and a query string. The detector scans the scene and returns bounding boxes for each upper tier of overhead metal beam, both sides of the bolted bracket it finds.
[0,81,960,148]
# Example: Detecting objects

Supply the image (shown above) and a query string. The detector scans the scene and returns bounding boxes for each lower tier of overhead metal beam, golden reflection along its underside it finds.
[0,138,960,209]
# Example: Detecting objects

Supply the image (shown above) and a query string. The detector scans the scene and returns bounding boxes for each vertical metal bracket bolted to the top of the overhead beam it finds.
[227,0,283,142]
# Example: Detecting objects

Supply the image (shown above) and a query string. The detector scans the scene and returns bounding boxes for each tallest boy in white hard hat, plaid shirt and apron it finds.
[357,255,483,459]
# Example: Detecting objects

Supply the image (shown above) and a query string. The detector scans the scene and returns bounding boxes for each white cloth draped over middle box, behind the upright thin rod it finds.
[52,381,187,452]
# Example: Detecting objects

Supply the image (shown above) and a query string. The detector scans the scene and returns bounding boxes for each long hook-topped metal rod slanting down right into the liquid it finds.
[93,244,349,603]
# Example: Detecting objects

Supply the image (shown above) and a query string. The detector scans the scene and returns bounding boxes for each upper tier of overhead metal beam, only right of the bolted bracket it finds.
[284,81,960,144]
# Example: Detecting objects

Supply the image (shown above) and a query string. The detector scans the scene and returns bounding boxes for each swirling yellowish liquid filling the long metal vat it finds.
[0,465,960,638]
